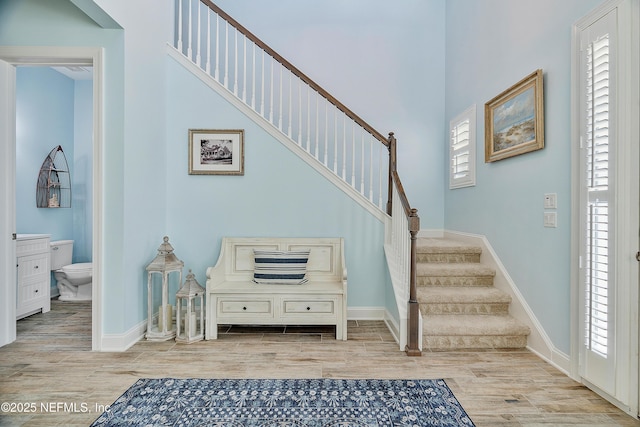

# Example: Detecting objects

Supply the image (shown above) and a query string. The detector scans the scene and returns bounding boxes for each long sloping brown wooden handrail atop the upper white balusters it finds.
[200,0,388,145]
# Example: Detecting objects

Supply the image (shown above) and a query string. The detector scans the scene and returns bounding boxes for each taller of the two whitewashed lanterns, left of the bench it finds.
[145,236,184,341]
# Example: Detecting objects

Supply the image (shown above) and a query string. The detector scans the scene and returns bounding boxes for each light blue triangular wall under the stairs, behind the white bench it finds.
[165,58,389,307]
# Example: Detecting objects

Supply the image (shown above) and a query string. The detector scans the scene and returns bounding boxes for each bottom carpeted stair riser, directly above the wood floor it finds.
[422,335,527,351]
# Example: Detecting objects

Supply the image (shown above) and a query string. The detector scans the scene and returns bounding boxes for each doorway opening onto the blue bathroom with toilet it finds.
[14,65,93,351]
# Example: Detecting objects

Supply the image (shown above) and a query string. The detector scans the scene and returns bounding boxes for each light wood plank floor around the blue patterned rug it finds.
[0,301,640,427]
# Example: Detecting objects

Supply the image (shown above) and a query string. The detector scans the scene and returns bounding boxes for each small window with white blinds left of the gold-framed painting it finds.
[449,105,476,189]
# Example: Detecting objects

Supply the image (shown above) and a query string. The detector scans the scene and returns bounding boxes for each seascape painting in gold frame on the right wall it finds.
[484,70,544,163]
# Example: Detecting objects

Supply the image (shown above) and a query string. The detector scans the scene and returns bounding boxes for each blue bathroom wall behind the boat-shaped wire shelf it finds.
[16,67,74,240]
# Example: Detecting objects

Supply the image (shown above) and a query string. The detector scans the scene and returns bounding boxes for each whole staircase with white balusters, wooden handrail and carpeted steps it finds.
[174,0,530,356]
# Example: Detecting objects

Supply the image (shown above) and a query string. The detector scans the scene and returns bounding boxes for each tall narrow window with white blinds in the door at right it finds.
[584,35,610,357]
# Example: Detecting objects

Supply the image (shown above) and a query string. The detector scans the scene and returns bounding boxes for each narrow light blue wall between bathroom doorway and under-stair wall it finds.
[95,0,172,333]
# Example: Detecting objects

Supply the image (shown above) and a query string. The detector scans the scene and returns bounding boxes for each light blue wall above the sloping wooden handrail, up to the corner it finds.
[215,0,446,229]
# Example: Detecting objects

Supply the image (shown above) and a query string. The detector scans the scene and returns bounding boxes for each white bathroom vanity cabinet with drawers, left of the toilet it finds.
[16,234,51,319]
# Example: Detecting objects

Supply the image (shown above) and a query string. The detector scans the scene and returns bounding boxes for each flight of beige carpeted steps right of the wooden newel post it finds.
[416,238,530,351]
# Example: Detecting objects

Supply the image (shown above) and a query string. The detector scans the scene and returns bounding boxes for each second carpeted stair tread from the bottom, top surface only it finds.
[418,286,511,304]
